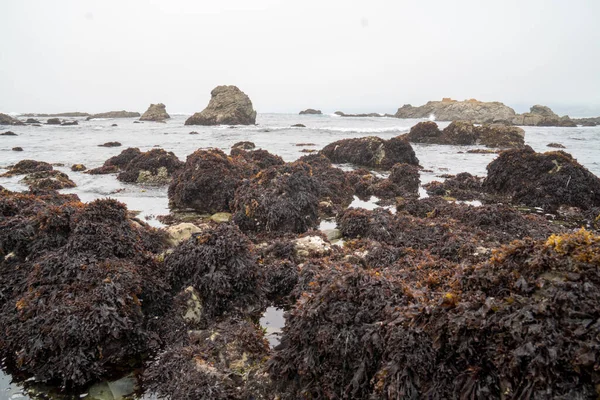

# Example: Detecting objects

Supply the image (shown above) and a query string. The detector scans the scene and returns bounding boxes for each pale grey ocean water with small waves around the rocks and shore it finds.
[0,114,600,400]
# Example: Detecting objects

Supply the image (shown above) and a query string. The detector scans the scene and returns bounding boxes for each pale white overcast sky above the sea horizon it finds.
[0,0,600,116]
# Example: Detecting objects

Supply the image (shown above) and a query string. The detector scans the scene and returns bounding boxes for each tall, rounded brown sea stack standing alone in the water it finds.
[185,86,256,125]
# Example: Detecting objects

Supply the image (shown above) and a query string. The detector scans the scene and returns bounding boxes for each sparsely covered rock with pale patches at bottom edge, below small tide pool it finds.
[142,320,271,400]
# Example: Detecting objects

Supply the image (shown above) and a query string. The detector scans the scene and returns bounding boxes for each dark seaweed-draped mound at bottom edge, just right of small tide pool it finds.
[269,265,407,399]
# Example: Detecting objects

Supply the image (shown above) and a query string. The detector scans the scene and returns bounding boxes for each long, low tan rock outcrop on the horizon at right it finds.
[394,98,516,124]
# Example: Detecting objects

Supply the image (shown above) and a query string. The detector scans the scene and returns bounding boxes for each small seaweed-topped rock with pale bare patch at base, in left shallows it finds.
[117,149,183,185]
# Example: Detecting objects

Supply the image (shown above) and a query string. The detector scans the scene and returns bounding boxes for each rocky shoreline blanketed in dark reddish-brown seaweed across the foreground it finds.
[0,122,600,399]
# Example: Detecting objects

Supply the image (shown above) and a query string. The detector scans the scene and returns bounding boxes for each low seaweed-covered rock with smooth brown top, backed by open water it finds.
[321,136,419,169]
